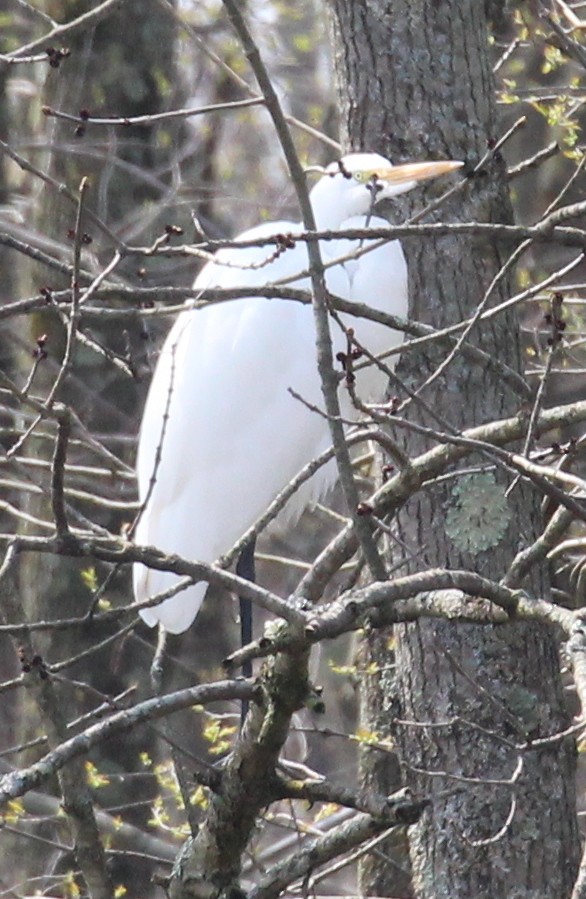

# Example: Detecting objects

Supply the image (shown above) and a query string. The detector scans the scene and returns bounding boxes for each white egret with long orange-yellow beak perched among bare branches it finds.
[134,153,461,633]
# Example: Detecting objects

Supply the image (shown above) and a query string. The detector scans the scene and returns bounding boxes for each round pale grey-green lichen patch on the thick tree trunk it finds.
[446,472,511,555]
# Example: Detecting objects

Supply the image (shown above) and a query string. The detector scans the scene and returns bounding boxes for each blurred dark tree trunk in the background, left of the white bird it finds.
[7,0,181,893]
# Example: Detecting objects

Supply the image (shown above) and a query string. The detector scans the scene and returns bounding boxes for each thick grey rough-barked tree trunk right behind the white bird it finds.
[331,0,578,899]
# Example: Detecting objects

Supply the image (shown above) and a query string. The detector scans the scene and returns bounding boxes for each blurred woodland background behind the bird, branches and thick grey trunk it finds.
[0,0,586,897]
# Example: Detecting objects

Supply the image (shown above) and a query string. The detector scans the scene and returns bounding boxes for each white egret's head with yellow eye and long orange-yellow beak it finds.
[311,153,463,230]
